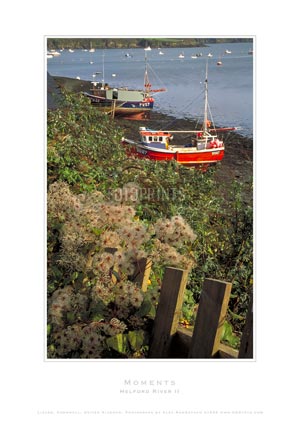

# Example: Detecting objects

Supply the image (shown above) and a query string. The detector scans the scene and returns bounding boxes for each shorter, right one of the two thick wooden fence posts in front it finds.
[189,279,232,358]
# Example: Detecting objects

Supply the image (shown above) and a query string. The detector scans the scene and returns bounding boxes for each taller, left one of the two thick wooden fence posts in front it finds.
[149,268,188,358]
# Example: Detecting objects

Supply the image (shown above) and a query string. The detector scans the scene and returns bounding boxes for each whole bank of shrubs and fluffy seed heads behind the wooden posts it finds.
[47,90,253,358]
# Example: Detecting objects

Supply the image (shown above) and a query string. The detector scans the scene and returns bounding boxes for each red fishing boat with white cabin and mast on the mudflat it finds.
[122,65,236,168]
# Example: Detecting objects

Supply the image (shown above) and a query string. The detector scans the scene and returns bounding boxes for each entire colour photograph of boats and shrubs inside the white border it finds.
[45,36,255,362]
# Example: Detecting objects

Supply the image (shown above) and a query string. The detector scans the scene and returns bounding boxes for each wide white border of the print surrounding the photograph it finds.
[1,0,299,423]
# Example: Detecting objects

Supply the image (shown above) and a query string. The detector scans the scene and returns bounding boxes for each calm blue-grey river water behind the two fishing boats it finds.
[47,43,253,137]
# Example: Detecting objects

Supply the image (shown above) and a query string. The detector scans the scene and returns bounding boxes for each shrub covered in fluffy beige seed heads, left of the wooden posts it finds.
[48,182,195,358]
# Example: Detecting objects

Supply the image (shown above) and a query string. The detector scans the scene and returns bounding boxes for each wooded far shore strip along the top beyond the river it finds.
[47,38,253,50]
